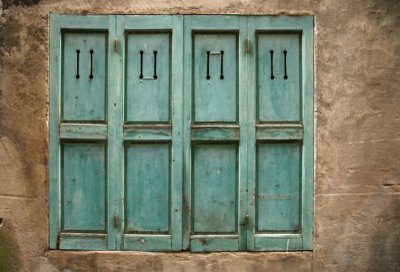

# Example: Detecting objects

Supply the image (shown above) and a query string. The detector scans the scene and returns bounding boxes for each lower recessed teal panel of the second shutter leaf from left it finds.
[125,144,170,233]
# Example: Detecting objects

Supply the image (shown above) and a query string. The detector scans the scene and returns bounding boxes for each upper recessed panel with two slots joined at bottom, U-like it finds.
[125,33,171,122]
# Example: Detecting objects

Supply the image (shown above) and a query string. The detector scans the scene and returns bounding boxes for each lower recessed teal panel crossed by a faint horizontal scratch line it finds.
[256,143,301,232]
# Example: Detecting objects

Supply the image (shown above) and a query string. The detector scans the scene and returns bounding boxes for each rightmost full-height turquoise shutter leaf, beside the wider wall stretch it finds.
[247,17,313,251]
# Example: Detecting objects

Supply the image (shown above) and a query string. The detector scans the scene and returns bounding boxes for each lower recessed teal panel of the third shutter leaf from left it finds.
[192,145,238,233]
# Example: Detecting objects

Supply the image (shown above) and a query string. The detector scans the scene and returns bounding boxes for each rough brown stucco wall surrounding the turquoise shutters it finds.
[0,0,400,271]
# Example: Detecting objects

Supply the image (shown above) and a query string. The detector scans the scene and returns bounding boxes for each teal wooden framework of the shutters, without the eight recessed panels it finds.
[48,14,314,252]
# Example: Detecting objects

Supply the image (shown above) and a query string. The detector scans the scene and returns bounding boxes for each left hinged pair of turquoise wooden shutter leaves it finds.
[49,14,183,251]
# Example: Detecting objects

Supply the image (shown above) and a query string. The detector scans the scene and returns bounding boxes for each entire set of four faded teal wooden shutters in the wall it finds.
[49,14,313,251]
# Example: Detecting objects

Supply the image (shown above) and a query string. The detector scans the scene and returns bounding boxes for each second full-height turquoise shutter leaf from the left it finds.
[121,16,182,251]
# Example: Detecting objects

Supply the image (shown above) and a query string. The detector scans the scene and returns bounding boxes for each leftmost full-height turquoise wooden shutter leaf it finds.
[49,15,115,250]
